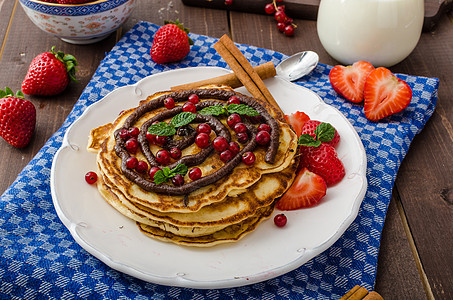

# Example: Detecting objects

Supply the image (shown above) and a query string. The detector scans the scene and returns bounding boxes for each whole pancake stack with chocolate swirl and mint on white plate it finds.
[88,86,297,247]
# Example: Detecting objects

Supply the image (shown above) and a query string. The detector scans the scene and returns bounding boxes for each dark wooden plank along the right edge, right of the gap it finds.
[392,13,453,299]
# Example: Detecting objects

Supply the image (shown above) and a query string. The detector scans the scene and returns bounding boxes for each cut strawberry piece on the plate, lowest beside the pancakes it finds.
[276,168,327,210]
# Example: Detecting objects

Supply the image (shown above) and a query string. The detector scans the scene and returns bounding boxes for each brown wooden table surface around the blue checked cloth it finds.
[0,0,453,299]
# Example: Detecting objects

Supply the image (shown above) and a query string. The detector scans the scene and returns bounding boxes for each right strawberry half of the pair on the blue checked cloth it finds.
[364,67,412,121]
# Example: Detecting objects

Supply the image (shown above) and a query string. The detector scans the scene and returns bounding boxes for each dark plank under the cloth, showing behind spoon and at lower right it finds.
[231,12,424,299]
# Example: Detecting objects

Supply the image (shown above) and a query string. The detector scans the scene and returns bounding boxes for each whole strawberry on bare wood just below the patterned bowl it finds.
[22,47,77,96]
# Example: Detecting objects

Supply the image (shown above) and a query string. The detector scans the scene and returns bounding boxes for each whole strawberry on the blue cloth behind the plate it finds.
[151,20,193,64]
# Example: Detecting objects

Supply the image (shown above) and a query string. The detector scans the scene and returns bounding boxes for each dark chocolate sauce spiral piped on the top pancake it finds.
[114,89,280,196]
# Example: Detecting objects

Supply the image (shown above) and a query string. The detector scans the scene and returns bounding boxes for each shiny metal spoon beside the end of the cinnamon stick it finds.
[275,51,319,81]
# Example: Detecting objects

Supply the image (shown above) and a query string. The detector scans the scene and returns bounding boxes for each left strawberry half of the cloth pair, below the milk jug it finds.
[329,61,374,103]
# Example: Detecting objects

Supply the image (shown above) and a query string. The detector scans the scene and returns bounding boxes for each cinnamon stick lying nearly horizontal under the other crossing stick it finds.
[171,61,277,91]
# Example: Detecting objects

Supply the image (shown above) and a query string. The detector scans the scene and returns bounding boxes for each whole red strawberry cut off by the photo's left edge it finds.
[0,88,36,148]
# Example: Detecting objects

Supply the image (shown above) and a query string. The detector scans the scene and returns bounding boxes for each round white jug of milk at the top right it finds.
[317,0,424,67]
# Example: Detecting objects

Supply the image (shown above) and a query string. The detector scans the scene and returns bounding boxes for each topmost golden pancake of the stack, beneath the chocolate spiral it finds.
[88,84,297,212]
